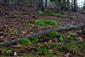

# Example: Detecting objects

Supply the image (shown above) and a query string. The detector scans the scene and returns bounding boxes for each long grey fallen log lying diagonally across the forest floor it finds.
[0,24,85,48]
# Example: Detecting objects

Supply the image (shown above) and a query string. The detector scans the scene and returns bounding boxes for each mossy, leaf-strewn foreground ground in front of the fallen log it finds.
[0,32,85,57]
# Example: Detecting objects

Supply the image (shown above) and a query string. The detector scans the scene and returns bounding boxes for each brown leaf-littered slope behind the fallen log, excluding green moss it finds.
[0,7,85,57]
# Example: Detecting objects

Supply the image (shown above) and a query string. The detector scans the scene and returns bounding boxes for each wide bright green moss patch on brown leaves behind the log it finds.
[35,20,58,27]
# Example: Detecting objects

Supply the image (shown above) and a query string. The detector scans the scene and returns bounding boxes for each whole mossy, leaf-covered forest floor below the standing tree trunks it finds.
[0,3,85,57]
